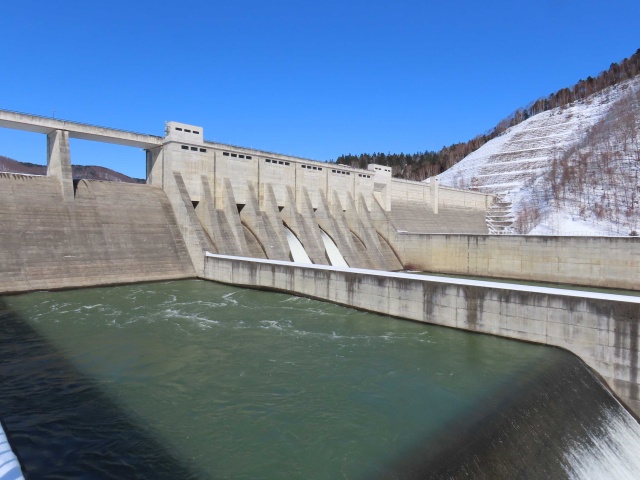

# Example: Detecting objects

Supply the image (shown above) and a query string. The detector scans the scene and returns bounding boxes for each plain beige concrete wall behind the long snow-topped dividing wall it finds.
[392,234,640,290]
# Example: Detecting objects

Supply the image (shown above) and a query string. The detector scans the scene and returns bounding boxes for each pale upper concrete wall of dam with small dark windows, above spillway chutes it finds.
[152,122,492,217]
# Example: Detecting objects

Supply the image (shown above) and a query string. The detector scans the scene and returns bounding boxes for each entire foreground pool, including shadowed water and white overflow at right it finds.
[0,280,640,479]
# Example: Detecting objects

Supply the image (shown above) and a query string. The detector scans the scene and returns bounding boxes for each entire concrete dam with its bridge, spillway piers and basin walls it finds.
[0,110,640,413]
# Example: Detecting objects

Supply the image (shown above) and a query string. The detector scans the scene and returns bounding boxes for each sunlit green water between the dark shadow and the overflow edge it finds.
[4,280,600,478]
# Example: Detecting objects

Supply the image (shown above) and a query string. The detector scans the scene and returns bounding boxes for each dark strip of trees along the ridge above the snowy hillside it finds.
[335,49,640,181]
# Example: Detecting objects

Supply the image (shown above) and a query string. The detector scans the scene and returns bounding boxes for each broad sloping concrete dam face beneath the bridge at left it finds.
[0,174,195,293]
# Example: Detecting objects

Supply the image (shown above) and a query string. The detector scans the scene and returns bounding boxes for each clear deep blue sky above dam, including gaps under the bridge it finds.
[0,0,640,177]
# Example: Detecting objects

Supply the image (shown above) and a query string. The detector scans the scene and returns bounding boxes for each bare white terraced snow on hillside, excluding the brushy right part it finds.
[440,77,640,235]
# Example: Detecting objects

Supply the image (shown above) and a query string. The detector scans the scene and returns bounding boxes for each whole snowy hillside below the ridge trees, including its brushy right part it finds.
[440,77,640,235]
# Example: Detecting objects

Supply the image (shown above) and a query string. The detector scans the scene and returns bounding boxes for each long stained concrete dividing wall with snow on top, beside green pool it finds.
[204,256,640,414]
